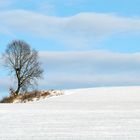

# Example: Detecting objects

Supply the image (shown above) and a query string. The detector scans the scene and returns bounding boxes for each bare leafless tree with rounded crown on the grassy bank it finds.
[3,40,43,95]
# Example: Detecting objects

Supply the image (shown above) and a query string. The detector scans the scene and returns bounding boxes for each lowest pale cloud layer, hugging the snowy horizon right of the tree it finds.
[39,73,140,89]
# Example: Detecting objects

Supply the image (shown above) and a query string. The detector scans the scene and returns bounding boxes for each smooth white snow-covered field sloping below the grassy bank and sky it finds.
[0,87,140,140]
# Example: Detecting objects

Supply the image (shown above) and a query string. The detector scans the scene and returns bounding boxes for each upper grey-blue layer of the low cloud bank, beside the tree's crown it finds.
[40,51,140,74]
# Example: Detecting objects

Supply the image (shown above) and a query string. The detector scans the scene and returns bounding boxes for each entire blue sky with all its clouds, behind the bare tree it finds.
[0,0,140,95]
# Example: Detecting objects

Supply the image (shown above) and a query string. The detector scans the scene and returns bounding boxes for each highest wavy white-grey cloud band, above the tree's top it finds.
[0,10,140,47]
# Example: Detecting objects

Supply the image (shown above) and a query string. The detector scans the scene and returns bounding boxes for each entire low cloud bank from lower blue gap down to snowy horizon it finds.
[0,51,140,89]
